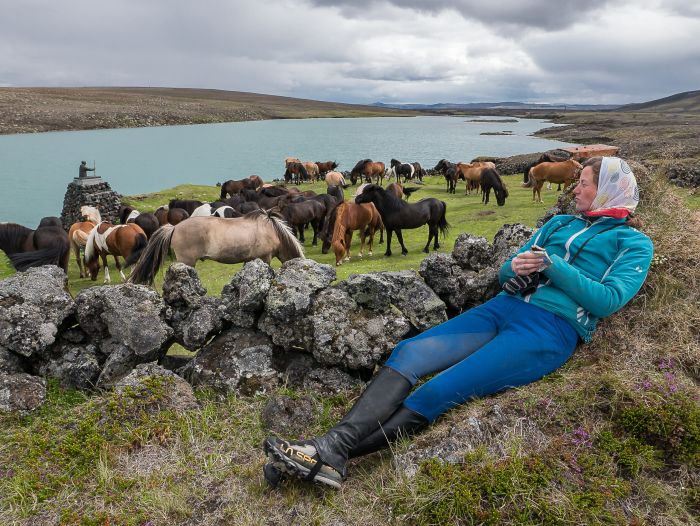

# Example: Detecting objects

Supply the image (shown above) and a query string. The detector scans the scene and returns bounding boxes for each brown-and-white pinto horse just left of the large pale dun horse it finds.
[85,222,148,283]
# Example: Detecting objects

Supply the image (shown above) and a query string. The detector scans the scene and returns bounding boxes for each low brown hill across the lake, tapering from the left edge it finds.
[0,87,415,134]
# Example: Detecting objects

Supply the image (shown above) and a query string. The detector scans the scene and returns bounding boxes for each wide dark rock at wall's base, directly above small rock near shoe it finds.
[180,328,279,395]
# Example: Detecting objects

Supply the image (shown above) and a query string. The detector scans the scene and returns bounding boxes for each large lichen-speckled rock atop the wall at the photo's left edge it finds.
[0,265,75,356]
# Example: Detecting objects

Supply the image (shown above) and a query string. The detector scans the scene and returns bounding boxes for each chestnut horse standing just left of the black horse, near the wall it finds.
[331,202,384,266]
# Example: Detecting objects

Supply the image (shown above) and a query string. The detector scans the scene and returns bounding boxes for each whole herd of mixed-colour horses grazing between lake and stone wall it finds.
[0,155,581,285]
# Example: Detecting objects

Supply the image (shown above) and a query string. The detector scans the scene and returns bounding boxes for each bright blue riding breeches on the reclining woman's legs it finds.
[385,295,578,422]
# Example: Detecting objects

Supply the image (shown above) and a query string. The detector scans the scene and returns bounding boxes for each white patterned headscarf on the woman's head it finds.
[590,157,639,213]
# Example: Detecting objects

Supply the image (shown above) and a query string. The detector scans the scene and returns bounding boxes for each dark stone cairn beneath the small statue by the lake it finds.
[61,176,121,230]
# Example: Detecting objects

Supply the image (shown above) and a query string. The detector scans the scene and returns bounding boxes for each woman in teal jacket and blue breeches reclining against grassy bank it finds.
[264,157,653,488]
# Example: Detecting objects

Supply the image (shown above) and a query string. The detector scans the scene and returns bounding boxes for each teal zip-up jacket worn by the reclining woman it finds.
[499,215,654,342]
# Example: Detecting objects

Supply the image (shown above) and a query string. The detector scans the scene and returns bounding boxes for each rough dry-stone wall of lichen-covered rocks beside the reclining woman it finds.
[0,225,532,411]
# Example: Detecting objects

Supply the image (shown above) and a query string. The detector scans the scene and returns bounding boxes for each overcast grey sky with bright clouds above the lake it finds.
[0,0,700,104]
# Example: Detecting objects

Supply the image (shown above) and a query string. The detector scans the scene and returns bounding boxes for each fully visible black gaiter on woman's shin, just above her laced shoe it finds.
[311,367,411,476]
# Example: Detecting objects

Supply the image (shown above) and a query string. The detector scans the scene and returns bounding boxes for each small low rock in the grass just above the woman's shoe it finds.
[261,396,320,438]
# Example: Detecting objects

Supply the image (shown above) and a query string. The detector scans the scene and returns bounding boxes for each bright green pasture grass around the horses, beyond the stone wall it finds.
[0,175,559,296]
